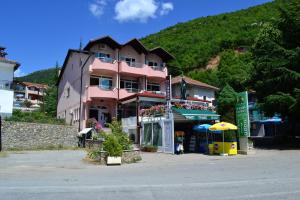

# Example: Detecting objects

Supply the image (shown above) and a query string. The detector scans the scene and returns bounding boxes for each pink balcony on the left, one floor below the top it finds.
[87,86,118,101]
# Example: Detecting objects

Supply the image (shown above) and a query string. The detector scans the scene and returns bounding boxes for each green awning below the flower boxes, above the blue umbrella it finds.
[172,108,220,120]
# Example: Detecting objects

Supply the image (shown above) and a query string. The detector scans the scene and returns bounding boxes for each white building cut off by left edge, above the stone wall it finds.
[0,47,20,117]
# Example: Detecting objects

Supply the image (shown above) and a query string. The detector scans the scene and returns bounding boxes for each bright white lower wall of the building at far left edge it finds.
[0,90,14,117]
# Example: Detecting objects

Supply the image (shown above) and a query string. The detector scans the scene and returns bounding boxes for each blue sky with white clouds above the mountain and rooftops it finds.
[0,0,271,76]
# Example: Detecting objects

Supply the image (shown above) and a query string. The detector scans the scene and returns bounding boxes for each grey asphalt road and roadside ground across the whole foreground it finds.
[0,150,300,200]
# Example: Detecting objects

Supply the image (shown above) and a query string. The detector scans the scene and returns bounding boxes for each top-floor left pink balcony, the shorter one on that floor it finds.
[89,58,118,74]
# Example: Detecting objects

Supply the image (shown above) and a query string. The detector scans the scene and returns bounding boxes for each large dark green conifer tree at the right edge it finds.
[252,0,300,136]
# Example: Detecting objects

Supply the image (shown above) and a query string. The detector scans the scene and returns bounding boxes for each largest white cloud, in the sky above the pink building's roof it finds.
[115,0,158,22]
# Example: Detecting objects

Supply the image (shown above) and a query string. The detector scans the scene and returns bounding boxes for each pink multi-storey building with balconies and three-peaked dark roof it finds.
[57,36,173,135]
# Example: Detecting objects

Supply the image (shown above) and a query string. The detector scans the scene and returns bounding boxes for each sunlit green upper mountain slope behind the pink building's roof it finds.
[142,2,279,74]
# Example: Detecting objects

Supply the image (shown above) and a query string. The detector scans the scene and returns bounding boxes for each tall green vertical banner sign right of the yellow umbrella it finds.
[235,92,250,137]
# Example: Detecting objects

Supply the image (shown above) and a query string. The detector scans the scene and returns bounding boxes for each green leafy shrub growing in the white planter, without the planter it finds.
[103,134,123,156]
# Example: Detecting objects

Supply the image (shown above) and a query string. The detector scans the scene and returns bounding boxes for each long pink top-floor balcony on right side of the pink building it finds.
[120,61,167,79]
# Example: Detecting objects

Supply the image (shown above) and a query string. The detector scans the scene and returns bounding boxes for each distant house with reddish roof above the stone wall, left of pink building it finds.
[14,81,48,110]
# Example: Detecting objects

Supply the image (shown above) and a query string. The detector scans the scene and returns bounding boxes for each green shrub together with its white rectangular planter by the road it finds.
[103,135,123,165]
